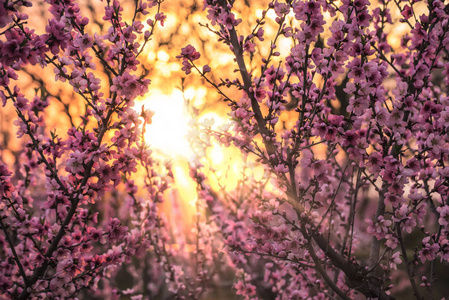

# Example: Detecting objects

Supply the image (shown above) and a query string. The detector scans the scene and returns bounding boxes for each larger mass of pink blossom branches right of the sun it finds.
[181,0,449,299]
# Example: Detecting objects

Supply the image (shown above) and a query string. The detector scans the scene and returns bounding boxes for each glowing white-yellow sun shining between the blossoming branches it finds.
[136,90,193,159]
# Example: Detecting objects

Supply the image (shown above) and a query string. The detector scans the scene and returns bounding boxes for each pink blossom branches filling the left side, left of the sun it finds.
[0,0,178,299]
